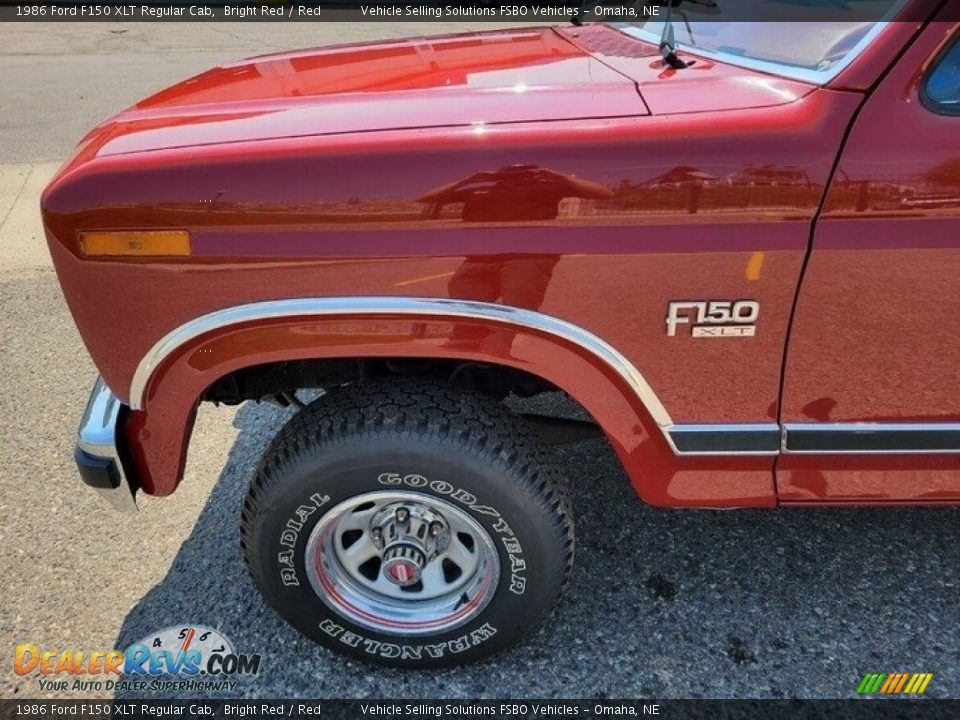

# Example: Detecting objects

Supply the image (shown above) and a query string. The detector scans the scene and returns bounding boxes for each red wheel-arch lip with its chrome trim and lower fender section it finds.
[124,297,774,507]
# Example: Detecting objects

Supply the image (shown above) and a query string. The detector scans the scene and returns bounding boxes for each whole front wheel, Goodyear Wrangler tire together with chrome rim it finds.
[241,381,573,668]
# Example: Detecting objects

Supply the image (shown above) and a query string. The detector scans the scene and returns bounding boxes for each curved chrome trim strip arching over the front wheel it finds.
[130,296,673,430]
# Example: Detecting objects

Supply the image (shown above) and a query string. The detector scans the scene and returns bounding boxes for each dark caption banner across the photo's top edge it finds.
[0,0,960,24]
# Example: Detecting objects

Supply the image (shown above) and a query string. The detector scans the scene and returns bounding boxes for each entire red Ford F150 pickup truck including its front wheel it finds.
[42,0,960,667]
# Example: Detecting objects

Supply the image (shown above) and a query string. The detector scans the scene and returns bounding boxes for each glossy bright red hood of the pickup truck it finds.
[90,28,648,155]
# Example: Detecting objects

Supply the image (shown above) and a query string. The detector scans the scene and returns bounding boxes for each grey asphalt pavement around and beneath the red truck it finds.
[0,23,960,699]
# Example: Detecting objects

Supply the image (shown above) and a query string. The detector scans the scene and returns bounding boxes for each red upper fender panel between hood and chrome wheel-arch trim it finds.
[45,91,858,422]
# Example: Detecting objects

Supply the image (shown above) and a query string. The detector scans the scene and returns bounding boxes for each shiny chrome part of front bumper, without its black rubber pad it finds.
[77,377,137,512]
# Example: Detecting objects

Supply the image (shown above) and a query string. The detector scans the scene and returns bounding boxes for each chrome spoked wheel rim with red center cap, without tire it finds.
[305,490,500,635]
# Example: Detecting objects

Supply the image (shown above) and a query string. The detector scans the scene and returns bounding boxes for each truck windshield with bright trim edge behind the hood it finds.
[617,0,906,84]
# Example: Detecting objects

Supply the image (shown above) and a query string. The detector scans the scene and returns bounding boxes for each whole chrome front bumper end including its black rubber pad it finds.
[74,378,137,512]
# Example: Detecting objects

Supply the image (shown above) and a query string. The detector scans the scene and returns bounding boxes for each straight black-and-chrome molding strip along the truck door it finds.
[781,422,960,455]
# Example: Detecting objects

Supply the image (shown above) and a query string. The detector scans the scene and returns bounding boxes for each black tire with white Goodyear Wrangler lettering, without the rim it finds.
[241,380,574,668]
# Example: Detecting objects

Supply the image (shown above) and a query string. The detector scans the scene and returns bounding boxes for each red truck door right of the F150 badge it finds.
[777,22,960,503]
